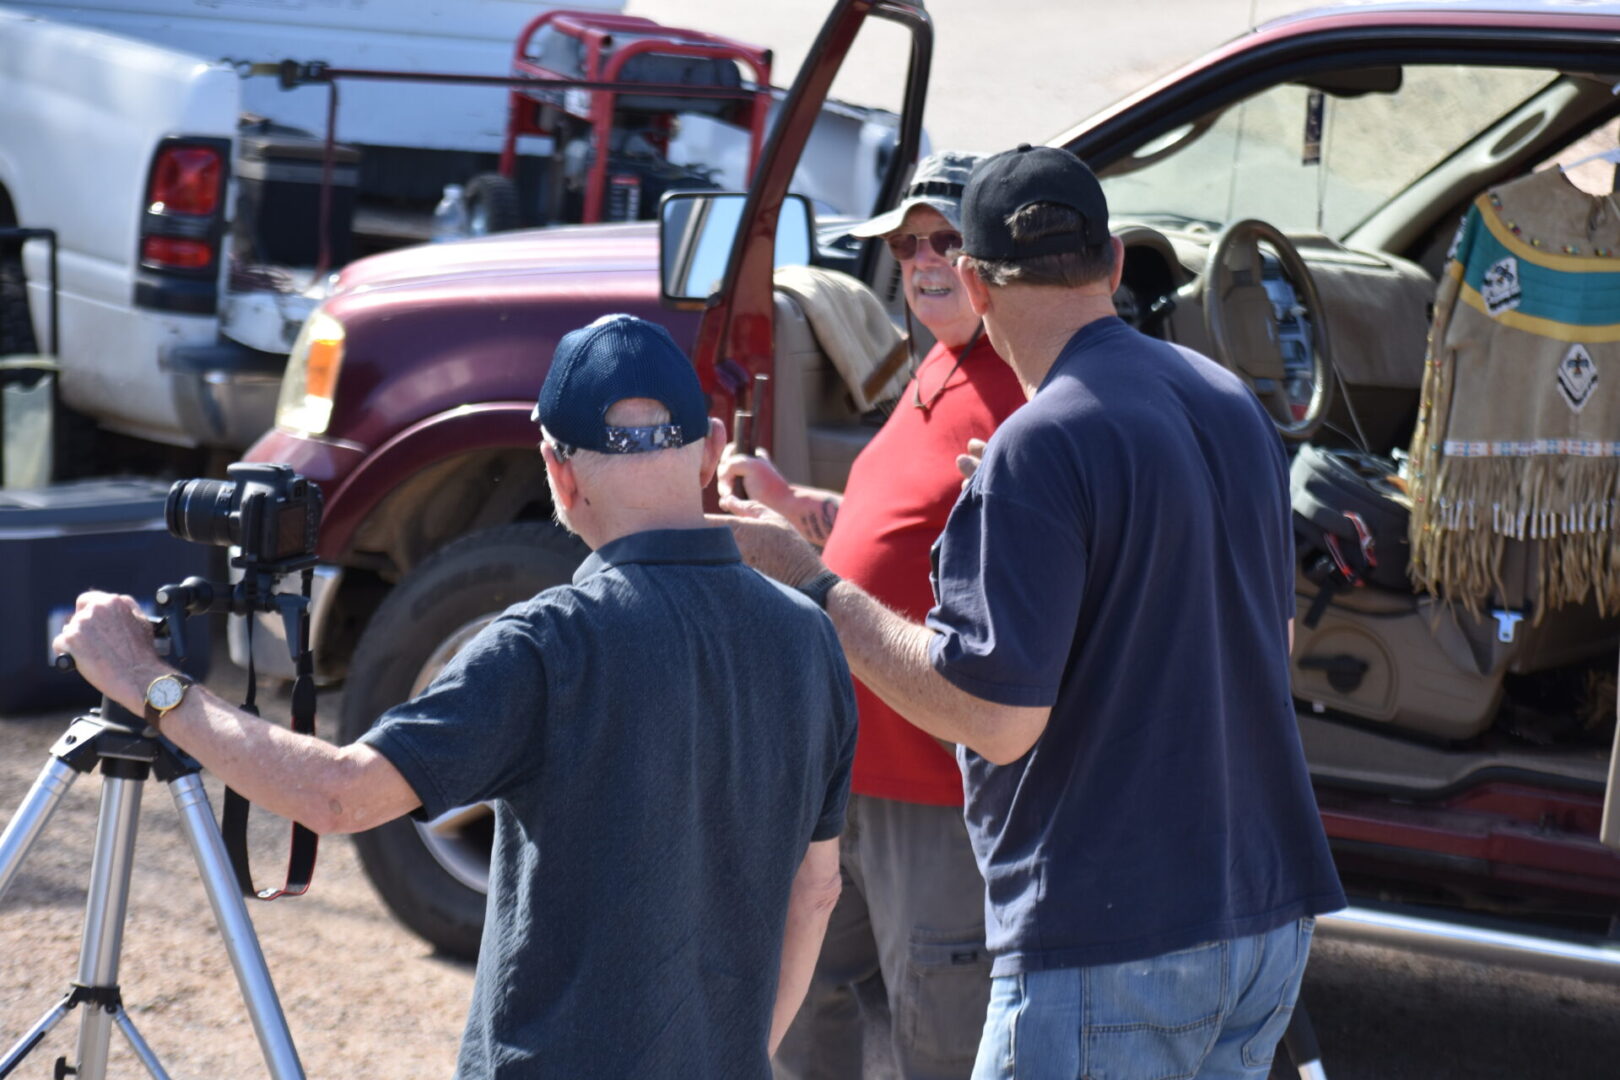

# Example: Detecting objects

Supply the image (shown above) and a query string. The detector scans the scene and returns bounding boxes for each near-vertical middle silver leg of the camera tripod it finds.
[75,776,143,1080]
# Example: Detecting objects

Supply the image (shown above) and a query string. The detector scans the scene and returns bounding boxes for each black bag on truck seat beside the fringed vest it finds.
[1290,444,1411,623]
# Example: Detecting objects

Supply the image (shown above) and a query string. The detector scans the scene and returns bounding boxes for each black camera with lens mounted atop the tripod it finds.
[164,461,322,573]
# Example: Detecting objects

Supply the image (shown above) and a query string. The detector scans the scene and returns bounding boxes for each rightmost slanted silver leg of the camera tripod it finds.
[168,772,305,1080]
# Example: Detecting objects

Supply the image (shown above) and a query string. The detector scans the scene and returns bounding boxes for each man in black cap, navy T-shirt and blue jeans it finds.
[722,147,1343,1080]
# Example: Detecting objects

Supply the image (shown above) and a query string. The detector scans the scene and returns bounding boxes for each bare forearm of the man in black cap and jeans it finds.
[826,581,1050,763]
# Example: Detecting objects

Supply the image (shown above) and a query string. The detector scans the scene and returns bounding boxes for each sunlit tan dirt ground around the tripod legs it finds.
[0,663,473,1080]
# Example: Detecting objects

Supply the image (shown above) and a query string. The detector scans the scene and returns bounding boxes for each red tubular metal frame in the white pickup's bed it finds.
[499,11,771,222]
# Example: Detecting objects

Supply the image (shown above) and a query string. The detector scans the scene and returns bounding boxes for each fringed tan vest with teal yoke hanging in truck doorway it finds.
[1411,168,1620,619]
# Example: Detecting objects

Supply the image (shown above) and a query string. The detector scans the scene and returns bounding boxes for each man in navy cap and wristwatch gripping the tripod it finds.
[57,316,855,1080]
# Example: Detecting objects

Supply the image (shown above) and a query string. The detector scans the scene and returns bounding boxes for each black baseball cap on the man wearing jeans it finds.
[962,142,1108,261]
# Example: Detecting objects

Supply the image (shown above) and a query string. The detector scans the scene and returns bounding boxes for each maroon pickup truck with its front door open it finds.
[233,0,1620,963]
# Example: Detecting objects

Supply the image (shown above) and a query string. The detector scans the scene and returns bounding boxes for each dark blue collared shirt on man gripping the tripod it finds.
[365,528,855,1080]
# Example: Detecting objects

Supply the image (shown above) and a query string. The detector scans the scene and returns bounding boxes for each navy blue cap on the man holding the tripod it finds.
[533,316,708,453]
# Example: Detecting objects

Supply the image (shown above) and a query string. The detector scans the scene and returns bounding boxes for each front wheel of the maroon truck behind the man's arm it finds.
[339,521,585,960]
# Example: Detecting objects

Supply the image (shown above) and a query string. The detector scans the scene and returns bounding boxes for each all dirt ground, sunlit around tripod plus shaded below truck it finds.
[0,660,1620,1080]
